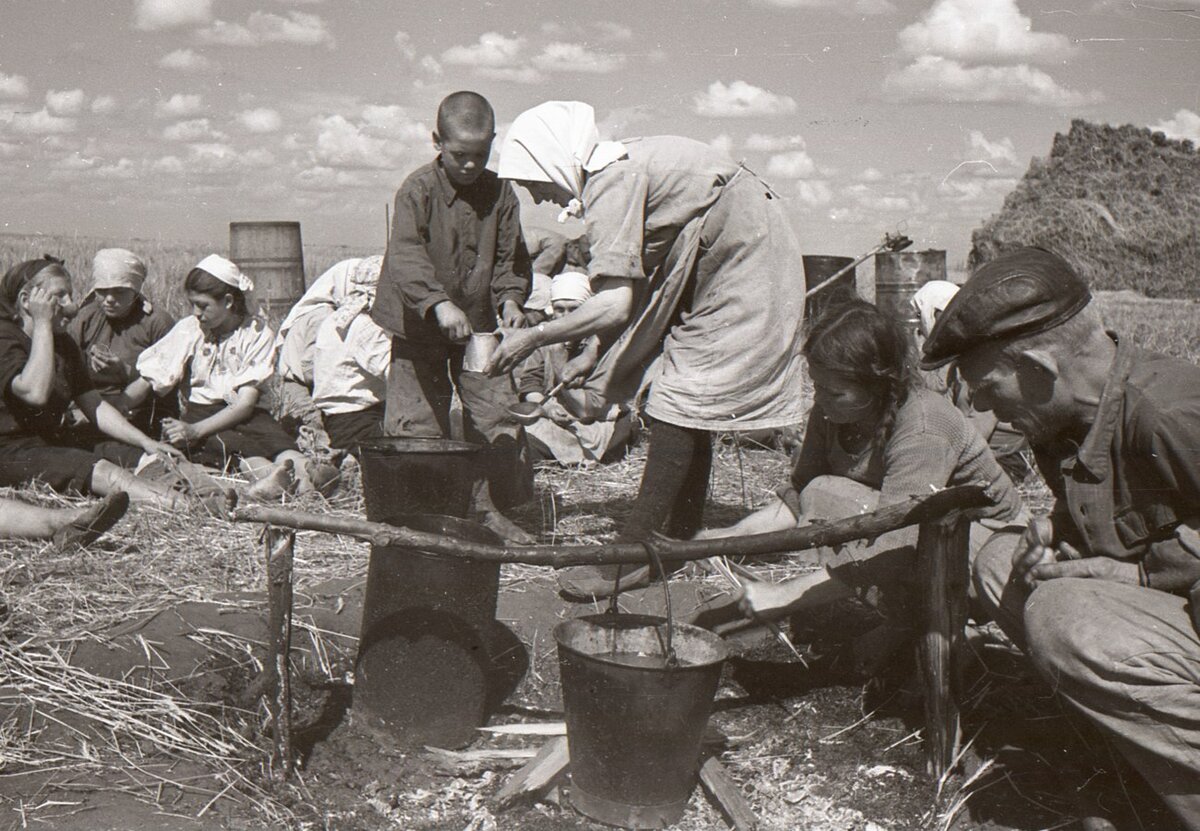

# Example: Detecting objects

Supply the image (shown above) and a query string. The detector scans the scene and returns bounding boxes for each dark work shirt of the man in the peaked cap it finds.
[1033,333,1200,594]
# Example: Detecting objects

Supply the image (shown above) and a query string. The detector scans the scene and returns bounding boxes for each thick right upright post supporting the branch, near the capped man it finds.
[917,513,971,779]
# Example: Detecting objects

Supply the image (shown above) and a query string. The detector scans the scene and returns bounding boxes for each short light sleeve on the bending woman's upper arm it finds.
[583,162,649,280]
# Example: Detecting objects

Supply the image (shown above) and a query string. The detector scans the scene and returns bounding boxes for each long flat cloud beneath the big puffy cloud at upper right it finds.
[883,55,1103,107]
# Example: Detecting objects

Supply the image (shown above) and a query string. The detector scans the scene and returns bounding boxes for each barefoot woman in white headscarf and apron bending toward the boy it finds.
[491,101,804,599]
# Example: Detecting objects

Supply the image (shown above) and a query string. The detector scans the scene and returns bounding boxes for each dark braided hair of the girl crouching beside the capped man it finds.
[802,298,920,454]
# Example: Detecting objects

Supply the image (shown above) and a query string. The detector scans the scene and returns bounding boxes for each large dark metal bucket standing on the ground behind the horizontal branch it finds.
[354,515,502,748]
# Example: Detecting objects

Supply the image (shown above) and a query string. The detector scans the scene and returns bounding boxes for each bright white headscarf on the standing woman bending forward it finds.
[499,101,625,199]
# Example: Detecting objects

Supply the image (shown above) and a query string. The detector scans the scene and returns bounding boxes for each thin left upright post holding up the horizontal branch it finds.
[263,526,296,781]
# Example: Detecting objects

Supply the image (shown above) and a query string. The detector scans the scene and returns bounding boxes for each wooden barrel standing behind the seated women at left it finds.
[229,222,305,319]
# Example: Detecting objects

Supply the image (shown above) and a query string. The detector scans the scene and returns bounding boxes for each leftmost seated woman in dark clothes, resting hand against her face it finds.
[0,256,206,509]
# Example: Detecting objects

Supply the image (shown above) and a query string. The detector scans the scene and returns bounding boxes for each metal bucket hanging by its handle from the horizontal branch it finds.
[554,614,728,829]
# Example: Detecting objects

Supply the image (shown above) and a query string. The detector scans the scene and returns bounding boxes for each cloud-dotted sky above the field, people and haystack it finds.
[0,0,1200,265]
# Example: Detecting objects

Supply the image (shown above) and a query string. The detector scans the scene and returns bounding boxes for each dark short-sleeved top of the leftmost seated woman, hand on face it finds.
[0,321,92,438]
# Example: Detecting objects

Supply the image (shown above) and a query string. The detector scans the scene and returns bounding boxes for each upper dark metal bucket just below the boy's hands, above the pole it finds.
[359,436,482,522]
